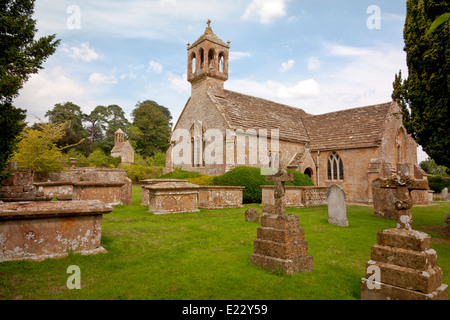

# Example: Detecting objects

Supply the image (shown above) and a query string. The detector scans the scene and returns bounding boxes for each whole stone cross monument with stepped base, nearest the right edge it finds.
[361,163,448,300]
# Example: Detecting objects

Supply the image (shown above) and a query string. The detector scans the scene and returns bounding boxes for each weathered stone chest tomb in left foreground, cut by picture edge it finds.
[0,200,113,262]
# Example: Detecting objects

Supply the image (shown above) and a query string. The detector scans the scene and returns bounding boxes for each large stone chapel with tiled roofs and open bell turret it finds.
[165,21,426,203]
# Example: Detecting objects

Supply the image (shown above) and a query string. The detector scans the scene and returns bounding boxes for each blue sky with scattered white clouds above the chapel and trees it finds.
[15,0,428,160]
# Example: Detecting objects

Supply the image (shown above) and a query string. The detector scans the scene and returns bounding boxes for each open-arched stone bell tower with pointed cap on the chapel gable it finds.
[187,20,230,93]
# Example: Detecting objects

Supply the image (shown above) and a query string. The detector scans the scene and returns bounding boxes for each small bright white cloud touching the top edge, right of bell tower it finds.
[241,0,286,24]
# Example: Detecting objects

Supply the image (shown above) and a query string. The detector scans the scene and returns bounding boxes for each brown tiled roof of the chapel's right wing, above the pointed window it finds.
[303,102,393,150]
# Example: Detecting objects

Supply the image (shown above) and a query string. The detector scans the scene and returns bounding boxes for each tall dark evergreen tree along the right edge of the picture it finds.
[392,0,450,167]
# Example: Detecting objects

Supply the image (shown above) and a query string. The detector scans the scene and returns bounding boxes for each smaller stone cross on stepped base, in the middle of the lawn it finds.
[249,170,313,275]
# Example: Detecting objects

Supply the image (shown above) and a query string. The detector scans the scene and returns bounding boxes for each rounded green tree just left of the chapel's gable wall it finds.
[129,103,171,157]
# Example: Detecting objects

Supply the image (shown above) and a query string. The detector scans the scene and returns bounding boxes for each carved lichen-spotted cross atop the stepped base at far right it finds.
[381,162,428,230]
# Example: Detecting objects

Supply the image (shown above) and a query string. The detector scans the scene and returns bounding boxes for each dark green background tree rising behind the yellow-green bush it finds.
[45,102,89,153]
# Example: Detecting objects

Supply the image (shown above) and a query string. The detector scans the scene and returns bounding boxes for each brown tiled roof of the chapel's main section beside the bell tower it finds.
[209,90,309,142]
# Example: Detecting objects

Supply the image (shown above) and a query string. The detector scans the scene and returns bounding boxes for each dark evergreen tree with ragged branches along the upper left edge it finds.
[0,0,60,182]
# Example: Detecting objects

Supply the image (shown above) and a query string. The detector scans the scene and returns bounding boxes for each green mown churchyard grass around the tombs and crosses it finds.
[0,186,450,300]
